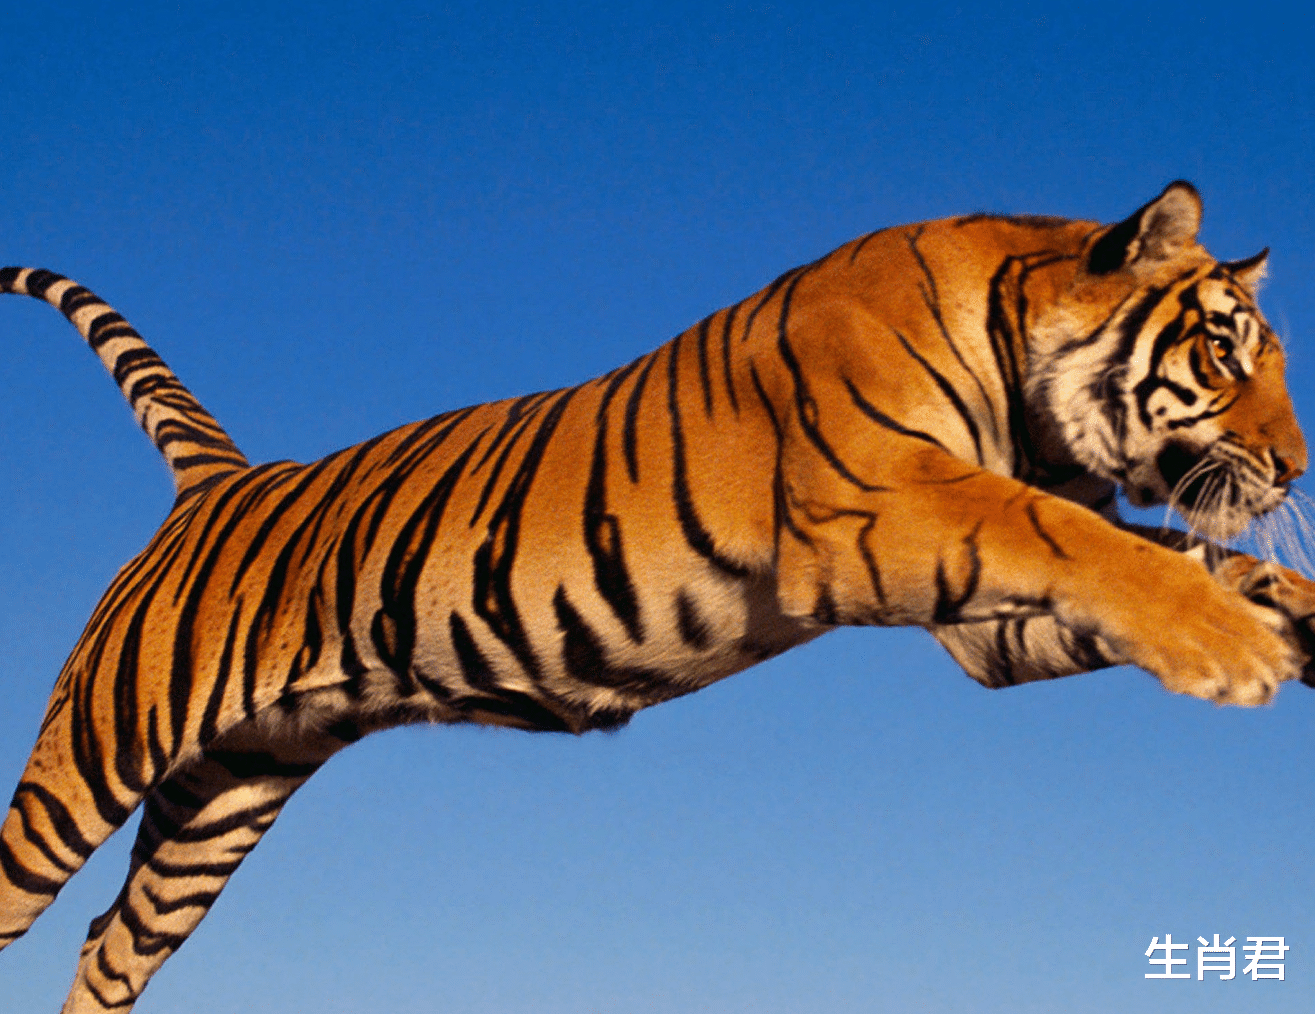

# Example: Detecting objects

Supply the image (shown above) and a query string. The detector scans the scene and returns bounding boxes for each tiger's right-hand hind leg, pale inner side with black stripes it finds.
[63,726,355,1014]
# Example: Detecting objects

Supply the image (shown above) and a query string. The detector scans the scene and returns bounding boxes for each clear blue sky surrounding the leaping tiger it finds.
[0,1,1315,1014]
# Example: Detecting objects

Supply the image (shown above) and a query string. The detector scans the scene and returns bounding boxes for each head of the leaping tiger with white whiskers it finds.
[1030,183,1306,539]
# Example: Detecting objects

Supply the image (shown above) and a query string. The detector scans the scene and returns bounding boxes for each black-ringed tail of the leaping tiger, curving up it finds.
[0,267,247,498]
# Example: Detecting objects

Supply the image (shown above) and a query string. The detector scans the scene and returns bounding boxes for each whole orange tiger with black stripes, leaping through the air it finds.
[0,181,1315,1014]
